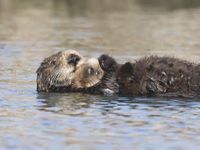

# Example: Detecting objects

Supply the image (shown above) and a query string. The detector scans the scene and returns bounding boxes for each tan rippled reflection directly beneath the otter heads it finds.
[37,93,100,115]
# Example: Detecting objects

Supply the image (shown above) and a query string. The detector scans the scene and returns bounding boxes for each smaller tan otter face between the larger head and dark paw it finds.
[71,58,104,89]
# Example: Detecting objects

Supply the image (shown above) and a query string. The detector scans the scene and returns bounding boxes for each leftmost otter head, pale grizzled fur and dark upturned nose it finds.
[37,50,83,92]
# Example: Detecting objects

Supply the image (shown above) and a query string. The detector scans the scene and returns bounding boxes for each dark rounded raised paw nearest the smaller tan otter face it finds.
[98,54,118,71]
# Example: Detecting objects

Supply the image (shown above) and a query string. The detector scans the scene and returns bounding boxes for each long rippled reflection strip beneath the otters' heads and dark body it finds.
[37,93,198,116]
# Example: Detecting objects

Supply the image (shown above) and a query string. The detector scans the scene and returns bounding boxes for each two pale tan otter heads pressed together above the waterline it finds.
[37,50,104,92]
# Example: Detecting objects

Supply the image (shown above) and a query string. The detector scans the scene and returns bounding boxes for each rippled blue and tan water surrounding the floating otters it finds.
[0,0,200,150]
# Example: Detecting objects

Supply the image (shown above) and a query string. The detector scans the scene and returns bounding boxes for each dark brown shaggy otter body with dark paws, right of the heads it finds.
[99,55,200,97]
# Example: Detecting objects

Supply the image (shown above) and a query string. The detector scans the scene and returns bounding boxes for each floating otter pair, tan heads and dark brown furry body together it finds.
[37,50,200,97]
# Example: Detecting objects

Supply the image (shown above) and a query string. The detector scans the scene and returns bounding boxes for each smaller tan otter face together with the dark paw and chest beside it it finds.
[70,55,119,96]
